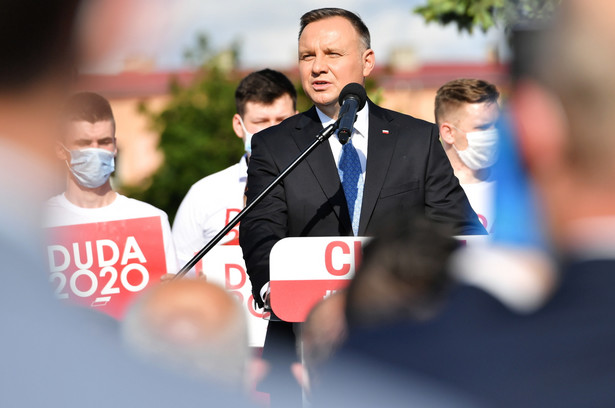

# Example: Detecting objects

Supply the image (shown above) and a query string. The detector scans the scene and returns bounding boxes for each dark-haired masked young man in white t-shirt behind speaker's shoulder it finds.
[173,69,297,266]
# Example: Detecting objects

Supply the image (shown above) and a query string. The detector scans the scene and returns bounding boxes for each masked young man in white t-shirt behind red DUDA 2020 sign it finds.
[44,92,177,293]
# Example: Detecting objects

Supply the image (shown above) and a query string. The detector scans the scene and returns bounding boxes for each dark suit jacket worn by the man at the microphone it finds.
[239,102,486,301]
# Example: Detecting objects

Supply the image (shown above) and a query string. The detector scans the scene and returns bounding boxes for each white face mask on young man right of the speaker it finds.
[453,128,498,170]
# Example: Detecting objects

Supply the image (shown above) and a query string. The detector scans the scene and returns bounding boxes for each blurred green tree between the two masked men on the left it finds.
[124,67,243,225]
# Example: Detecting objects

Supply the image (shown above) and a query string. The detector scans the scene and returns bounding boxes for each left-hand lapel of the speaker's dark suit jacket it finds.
[293,107,352,231]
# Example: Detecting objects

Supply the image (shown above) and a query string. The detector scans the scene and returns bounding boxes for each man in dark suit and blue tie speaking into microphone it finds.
[240,9,486,408]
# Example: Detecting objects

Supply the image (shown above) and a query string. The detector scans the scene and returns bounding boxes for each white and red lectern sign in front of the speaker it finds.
[269,237,369,322]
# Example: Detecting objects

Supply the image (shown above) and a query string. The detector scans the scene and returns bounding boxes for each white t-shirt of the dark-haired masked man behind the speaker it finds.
[173,156,248,266]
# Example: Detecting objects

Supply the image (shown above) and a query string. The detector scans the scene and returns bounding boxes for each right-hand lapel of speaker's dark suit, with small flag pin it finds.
[359,101,399,235]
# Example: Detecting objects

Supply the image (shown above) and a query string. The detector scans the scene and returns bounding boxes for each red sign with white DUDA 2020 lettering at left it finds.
[47,217,166,319]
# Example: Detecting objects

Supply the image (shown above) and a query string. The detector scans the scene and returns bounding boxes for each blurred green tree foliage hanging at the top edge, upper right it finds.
[414,0,561,34]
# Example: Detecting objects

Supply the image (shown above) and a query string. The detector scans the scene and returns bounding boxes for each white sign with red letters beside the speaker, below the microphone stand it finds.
[196,245,268,347]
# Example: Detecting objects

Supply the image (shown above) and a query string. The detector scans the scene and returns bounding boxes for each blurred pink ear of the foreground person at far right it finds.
[511,81,568,176]
